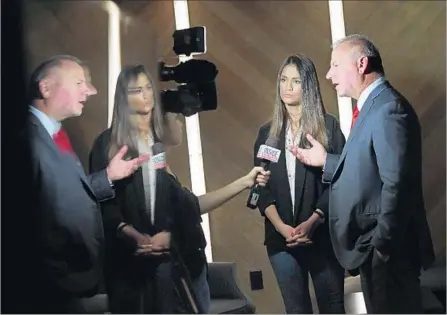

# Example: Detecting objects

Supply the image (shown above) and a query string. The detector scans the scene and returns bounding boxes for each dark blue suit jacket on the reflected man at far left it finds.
[23,113,114,303]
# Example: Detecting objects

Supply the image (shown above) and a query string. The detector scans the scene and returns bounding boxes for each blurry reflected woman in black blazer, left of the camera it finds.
[90,65,175,314]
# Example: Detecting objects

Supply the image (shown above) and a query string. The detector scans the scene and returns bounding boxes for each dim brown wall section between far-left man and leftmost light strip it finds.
[24,0,108,167]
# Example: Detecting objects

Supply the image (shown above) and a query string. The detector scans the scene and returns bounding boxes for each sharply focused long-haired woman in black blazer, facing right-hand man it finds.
[254,55,345,314]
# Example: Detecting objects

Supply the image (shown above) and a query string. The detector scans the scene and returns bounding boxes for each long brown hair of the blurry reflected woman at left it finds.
[109,64,164,158]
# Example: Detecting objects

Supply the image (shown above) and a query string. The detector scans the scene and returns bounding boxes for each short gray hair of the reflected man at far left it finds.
[28,55,84,101]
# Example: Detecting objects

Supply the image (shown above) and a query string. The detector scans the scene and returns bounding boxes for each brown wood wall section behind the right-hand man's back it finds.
[344,1,446,253]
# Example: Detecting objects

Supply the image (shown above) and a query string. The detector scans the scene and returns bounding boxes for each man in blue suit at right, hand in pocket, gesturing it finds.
[296,35,434,313]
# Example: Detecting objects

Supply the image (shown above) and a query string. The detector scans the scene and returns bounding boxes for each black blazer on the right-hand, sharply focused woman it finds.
[254,115,345,255]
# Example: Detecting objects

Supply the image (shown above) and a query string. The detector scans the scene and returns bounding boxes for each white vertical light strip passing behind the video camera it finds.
[173,0,213,262]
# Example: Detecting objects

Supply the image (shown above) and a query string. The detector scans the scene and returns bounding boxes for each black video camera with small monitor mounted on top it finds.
[158,26,219,116]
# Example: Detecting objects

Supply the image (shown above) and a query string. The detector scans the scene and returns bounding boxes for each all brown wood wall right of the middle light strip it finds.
[189,1,446,312]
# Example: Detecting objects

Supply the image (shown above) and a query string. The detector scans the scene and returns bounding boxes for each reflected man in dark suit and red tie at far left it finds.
[12,56,148,313]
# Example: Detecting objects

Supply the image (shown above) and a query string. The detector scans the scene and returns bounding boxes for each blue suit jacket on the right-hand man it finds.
[323,82,434,270]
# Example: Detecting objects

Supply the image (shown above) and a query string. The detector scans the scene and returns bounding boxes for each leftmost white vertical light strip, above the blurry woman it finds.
[107,1,121,127]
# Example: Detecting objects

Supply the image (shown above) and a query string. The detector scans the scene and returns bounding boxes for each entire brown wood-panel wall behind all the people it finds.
[26,0,446,313]
